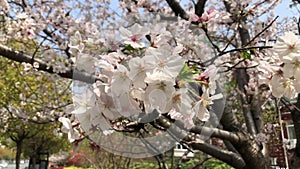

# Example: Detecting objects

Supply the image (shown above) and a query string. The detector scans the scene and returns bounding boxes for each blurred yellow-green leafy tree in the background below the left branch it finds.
[0,40,71,168]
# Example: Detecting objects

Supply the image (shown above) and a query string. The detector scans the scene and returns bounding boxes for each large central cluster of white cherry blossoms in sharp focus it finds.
[63,17,222,141]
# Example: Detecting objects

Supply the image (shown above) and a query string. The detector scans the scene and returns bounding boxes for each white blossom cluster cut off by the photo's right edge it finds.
[270,32,300,99]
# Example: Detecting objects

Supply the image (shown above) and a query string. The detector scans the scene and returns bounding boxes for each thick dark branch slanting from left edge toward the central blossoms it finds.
[0,44,96,83]
